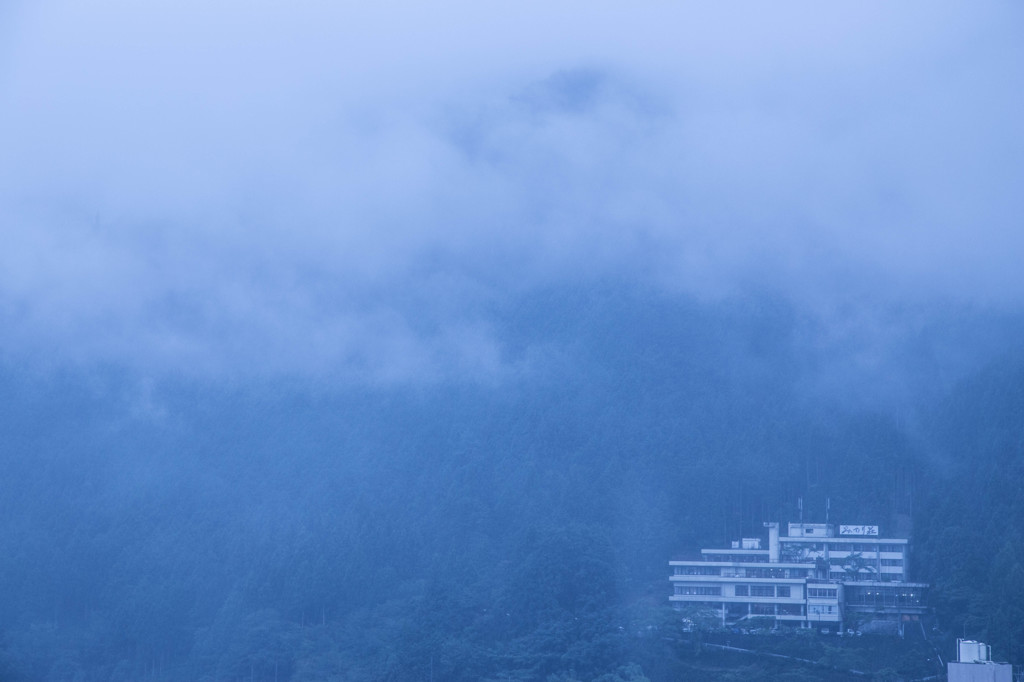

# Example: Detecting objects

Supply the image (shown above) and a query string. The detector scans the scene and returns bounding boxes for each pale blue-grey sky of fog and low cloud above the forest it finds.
[0,0,1024,381]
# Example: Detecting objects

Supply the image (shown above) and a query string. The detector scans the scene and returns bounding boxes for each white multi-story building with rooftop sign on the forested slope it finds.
[669,522,928,629]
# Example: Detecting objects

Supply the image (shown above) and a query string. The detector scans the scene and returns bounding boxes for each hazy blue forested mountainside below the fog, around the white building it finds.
[0,287,1024,682]
